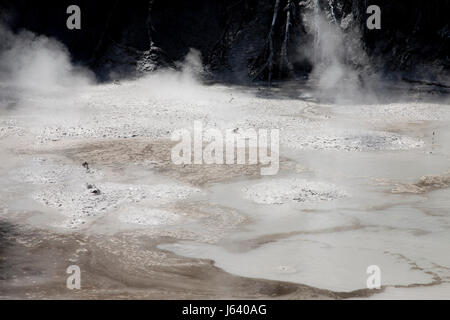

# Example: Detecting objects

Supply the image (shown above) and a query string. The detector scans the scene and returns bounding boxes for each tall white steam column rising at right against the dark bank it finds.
[301,2,376,102]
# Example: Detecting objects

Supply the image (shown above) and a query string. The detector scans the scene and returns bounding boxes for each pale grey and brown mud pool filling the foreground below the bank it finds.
[0,78,450,299]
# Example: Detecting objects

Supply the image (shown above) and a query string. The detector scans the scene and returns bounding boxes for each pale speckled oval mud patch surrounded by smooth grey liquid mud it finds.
[242,179,346,204]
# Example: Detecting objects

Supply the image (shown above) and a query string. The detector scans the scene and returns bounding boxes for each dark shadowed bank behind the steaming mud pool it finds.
[0,0,450,81]
